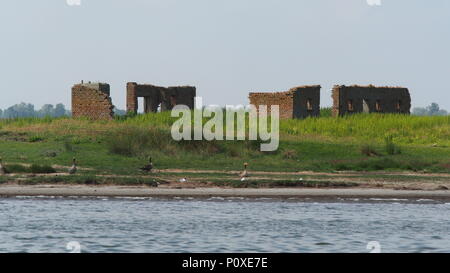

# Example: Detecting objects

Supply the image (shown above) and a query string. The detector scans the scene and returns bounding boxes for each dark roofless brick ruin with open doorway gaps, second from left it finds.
[127,82,196,113]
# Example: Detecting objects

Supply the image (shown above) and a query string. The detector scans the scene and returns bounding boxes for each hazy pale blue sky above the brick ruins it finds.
[0,0,450,110]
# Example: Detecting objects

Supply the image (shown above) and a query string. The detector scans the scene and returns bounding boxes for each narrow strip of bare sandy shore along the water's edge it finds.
[0,185,450,199]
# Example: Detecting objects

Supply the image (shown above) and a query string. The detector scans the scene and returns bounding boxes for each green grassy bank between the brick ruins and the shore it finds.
[0,109,450,179]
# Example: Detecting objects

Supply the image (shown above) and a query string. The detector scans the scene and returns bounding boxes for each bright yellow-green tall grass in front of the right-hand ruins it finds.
[280,114,450,145]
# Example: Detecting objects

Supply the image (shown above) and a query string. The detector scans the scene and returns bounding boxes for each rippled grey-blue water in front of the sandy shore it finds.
[0,197,450,252]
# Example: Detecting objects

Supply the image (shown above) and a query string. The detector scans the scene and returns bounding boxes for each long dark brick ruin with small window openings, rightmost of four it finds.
[331,85,411,116]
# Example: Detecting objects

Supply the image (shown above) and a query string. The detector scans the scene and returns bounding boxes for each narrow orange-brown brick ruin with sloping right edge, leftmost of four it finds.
[72,83,114,119]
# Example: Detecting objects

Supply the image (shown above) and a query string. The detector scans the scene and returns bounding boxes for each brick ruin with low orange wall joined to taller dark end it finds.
[249,85,321,119]
